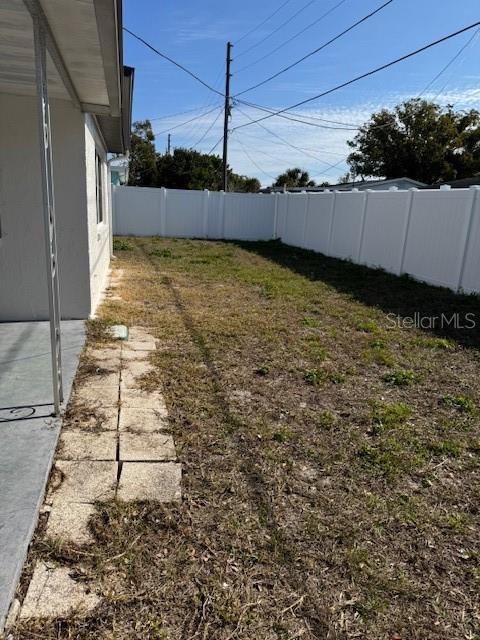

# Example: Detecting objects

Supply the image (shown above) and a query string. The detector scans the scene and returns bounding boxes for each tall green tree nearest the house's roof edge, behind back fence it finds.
[128,120,157,187]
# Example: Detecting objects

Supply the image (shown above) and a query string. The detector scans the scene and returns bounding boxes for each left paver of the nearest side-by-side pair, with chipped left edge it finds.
[48,460,117,506]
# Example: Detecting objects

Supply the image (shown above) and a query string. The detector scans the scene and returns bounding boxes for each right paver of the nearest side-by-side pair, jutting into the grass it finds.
[117,462,182,502]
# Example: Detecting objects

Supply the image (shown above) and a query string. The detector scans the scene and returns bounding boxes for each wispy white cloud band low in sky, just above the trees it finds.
[156,88,480,185]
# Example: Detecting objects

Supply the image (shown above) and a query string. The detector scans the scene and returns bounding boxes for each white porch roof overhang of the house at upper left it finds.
[0,0,133,153]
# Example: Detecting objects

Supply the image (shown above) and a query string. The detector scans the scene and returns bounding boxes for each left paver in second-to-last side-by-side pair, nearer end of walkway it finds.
[57,429,117,460]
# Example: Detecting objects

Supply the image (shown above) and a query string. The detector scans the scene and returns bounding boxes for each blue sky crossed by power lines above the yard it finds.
[124,0,480,184]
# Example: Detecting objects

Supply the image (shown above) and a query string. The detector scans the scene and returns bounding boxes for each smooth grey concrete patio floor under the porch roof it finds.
[0,321,85,629]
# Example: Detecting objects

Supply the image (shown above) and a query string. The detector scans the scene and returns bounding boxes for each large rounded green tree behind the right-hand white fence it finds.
[348,99,480,184]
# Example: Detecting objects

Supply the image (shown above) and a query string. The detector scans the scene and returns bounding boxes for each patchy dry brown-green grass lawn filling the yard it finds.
[15,239,480,640]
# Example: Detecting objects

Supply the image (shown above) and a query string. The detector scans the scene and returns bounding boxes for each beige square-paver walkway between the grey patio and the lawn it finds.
[15,327,181,619]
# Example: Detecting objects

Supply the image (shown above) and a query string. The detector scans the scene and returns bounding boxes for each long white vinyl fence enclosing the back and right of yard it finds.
[114,187,480,293]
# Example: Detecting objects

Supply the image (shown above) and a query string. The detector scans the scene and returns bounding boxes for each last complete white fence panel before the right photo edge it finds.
[403,189,472,290]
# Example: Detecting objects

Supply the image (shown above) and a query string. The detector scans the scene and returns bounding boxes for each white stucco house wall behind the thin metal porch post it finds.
[0,93,111,321]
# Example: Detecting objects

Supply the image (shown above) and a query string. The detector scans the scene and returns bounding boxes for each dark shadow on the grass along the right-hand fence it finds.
[233,241,480,349]
